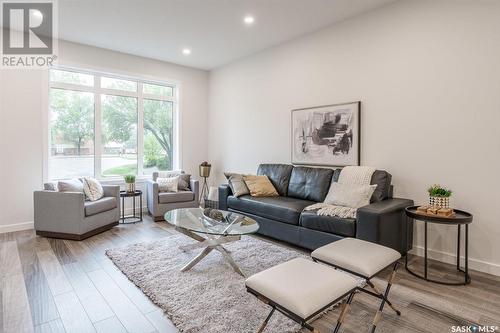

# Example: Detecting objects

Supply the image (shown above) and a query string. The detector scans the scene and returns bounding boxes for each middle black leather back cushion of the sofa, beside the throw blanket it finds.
[288,167,333,202]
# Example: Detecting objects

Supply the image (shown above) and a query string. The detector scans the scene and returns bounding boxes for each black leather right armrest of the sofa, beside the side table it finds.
[356,198,413,255]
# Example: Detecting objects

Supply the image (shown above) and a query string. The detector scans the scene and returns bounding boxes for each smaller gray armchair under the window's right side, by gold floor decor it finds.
[147,172,200,221]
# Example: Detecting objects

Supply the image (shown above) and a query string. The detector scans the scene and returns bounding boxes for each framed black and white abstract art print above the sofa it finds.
[292,102,361,166]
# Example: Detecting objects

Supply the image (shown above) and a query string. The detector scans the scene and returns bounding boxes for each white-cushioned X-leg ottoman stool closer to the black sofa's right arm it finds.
[311,238,401,332]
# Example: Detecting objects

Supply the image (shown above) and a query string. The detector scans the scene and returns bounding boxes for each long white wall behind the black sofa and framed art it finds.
[209,0,500,275]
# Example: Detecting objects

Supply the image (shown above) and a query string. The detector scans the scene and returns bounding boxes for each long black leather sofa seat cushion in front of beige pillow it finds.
[227,195,314,225]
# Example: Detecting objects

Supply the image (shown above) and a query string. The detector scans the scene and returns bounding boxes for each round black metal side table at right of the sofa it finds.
[405,206,472,286]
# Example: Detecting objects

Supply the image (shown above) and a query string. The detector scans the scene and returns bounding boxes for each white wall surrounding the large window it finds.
[0,41,208,232]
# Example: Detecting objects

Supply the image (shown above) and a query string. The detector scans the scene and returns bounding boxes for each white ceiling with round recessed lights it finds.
[58,0,394,70]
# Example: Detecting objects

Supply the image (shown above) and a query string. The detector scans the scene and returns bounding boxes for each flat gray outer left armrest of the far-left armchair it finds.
[33,191,85,234]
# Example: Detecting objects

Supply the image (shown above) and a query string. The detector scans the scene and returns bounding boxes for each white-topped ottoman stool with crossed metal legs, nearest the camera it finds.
[245,258,358,333]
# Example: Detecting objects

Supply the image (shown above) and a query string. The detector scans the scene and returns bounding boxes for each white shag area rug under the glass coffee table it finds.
[106,235,322,333]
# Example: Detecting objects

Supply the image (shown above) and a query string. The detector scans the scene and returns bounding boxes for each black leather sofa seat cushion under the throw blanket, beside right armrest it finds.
[300,210,356,237]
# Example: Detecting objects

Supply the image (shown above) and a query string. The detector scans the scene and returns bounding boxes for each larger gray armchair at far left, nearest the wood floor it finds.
[33,185,120,240]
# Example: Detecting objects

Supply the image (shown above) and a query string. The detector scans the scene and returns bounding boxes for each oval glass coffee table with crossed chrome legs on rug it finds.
[165,208,259,276]
